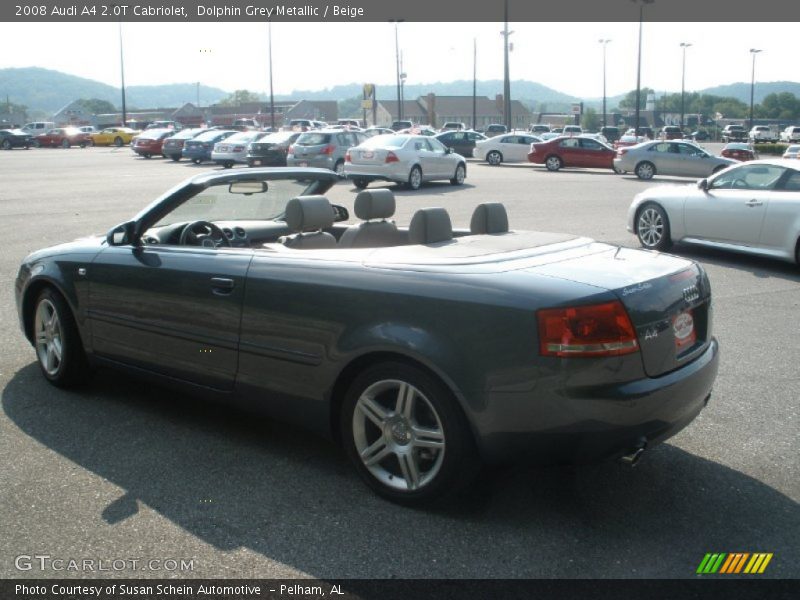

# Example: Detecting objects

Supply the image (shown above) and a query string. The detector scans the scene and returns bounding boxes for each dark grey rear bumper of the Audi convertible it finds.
[478,339,719,464]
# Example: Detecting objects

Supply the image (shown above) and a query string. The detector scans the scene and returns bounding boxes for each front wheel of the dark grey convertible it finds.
[31,288,91,387]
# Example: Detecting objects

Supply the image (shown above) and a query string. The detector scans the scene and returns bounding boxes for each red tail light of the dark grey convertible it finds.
[536,300,639,358]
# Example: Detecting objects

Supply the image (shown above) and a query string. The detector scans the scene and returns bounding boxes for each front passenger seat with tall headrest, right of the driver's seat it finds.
[339,189,404,248]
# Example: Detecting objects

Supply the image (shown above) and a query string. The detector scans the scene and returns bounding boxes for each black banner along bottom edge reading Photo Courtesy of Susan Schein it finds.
[0,577,800,600]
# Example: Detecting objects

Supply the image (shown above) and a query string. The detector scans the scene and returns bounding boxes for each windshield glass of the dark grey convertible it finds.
[154,179,318,227]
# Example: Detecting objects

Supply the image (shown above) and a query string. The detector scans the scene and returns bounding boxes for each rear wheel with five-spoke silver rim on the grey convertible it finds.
[340,362,480,506]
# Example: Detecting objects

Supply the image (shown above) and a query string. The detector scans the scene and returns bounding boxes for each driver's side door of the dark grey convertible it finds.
[88,246,252,390]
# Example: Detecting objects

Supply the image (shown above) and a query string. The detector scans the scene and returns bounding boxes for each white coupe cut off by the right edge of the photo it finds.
[628,158,800,264]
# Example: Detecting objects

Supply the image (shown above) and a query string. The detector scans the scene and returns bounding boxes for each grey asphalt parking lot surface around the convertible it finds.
[0,148,800,578]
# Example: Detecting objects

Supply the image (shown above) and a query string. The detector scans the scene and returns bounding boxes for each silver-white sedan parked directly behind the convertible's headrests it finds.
[344,134,467,190]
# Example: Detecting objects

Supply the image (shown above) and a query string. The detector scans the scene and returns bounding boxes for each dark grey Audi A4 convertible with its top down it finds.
[16,168,718,504]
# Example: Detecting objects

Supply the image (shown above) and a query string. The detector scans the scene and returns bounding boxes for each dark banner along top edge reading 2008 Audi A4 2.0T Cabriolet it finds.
[0,0,800,24]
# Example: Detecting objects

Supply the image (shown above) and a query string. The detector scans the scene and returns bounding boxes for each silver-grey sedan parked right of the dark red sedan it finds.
[614,141,737,179]
